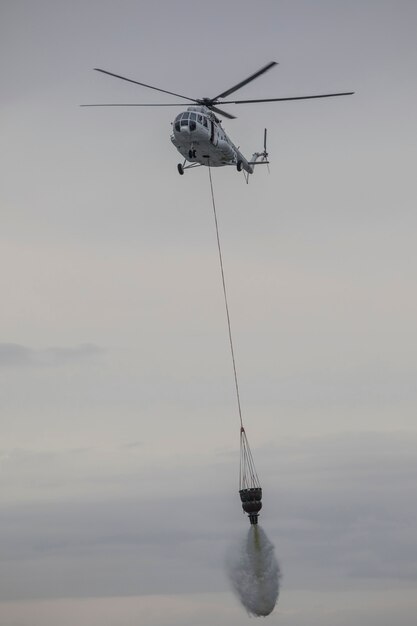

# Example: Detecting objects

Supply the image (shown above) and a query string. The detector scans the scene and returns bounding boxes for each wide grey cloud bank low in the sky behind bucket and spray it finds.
[0,432,417,600]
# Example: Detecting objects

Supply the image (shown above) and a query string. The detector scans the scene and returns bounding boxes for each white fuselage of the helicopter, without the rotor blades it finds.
[171,106,257,174]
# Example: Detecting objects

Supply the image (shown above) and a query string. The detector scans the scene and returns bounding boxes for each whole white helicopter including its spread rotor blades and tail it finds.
[81,61,354,177]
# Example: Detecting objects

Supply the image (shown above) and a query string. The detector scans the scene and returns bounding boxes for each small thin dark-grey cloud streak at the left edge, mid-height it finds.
[0,343,102,367]
